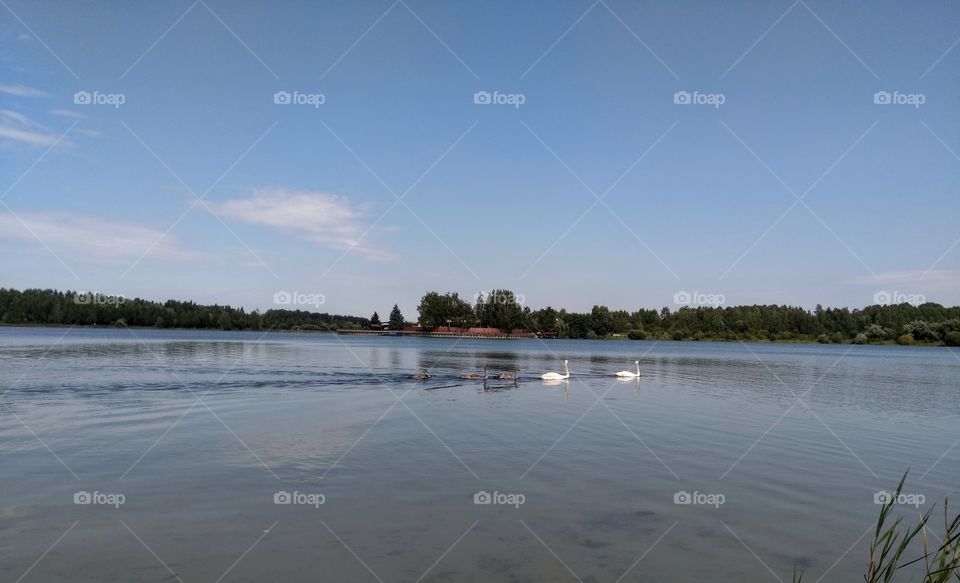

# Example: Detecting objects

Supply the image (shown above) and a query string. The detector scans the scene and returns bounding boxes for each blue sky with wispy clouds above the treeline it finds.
[0,0,960,317]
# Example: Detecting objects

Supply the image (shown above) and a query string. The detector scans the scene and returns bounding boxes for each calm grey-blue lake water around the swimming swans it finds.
[0,328,960,583]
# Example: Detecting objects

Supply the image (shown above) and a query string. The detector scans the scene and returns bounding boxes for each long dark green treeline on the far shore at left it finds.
[0,288,370,330]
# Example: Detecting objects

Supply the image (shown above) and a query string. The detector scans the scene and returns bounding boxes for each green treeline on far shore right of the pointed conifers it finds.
[418,289,960,346]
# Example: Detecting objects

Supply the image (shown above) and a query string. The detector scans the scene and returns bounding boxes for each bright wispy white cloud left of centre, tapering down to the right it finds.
[211,188,395,259]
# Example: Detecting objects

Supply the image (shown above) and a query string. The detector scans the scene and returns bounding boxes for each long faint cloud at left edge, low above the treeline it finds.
[0,213,204,261]
